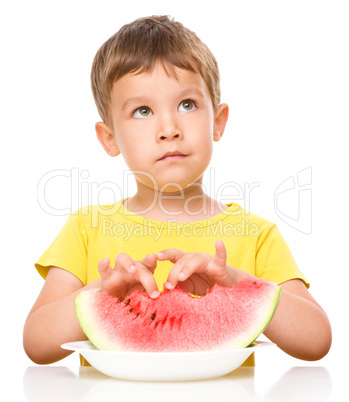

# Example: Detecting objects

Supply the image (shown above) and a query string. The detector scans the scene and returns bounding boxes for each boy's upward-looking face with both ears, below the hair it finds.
[96,66,228,192]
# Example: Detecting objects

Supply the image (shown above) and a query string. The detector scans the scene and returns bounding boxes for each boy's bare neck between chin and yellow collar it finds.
[125,178,227,222]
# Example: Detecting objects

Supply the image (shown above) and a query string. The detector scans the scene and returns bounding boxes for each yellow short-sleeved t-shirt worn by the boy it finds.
[35,199,309,368]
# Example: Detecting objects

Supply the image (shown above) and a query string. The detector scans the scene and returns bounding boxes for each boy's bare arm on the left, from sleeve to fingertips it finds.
[23,254,159,364]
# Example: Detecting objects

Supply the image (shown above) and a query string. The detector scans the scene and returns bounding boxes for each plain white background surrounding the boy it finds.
[0,0,349,398]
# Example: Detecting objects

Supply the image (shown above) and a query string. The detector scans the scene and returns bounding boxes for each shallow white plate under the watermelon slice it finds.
[62,341,274,381]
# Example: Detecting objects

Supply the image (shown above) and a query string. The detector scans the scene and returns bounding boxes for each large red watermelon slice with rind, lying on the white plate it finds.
[75,278,281,352]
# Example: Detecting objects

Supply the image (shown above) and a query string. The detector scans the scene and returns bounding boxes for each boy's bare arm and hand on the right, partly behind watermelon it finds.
[158,241,332,360]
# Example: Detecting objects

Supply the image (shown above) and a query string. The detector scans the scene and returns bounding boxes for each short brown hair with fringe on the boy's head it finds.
[91,16,220,126]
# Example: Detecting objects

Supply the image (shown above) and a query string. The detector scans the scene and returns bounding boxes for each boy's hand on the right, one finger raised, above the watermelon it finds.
[156,240,237,296]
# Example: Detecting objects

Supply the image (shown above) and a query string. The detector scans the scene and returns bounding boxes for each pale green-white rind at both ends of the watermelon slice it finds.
[75,286,282,351]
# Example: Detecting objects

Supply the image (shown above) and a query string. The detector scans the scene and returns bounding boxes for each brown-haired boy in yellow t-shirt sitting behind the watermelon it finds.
[24,17,331,364]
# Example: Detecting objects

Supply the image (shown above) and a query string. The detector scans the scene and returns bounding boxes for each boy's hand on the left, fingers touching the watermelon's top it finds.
[98,253,160,298]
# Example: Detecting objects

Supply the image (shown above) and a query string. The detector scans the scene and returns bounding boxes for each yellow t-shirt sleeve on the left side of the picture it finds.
[35,213,88,285]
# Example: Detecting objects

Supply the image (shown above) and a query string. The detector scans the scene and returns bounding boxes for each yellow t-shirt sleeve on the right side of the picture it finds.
[256,224,309,288]
